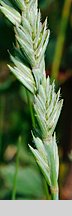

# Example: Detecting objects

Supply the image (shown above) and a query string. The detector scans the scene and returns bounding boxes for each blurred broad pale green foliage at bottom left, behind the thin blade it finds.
[0,164,45,199]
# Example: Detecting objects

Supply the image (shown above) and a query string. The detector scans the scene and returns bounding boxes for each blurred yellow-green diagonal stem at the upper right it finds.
[51,0,72,79]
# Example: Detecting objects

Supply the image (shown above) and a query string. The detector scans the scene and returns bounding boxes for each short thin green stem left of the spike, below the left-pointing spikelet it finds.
[27,91,35,128]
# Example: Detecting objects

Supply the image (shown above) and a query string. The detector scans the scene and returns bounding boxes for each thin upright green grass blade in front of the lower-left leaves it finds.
[12,137,21,200]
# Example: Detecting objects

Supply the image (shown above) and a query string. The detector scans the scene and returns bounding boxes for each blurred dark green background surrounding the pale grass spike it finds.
[0,0,72,199]
